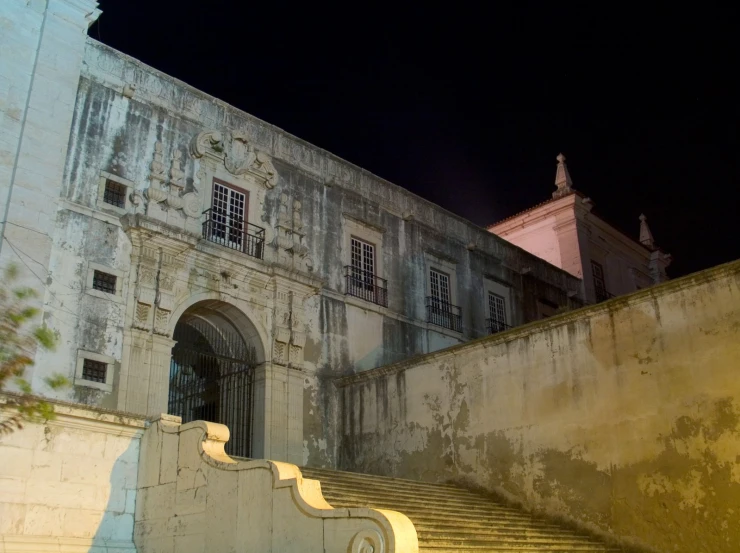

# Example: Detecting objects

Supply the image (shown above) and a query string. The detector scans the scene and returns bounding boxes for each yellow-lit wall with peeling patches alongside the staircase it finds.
[336,262,740,553]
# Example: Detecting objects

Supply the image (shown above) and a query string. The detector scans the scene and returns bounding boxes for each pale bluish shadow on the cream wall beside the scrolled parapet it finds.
[89,437,140,553]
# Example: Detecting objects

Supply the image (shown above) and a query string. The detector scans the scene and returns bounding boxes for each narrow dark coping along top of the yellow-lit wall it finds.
[331,259,740,388]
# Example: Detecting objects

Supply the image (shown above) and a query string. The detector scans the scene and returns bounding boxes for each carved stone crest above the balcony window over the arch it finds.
[190,130,278,188]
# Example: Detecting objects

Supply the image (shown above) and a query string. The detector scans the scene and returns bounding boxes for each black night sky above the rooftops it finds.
[90,0,740,277]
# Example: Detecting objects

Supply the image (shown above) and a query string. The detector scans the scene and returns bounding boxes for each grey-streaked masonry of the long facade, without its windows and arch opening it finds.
[21,35,580,465]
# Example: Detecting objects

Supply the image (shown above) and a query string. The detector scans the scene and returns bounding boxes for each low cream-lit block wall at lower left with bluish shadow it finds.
[0,396,144,553]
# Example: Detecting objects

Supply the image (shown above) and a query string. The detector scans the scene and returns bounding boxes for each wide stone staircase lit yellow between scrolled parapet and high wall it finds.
[301,468,621,553]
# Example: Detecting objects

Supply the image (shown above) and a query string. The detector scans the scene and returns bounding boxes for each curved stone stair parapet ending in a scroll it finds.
[134,418,418,553]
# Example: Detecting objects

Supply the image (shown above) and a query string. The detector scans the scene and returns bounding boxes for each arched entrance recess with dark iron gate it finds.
[167,300,264,457]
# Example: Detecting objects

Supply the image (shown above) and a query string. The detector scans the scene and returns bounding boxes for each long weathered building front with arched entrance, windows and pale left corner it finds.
[0,0,582,465]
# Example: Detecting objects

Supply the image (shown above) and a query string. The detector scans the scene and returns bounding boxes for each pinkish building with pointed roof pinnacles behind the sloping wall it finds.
[488,154,671,304]
